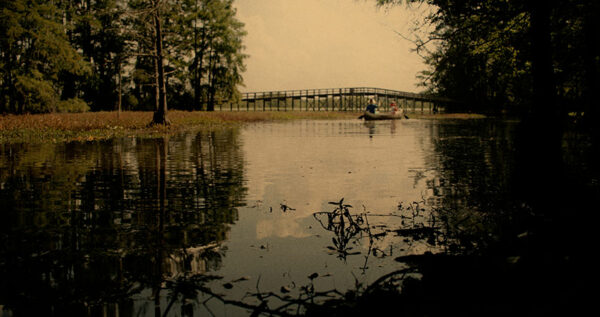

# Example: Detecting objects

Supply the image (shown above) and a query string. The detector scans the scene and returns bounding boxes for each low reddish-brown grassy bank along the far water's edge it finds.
[0,110,480,143]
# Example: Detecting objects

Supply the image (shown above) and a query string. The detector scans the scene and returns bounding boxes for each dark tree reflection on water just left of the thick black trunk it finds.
[415,120,514,251]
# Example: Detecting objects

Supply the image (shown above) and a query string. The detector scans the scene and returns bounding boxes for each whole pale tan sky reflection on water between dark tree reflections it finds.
[211,120,432,306]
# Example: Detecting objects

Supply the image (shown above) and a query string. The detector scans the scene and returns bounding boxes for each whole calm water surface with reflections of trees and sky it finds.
[0,120,514,316]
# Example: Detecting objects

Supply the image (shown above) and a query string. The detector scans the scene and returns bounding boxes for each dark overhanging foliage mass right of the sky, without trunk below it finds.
[378,0,600,118]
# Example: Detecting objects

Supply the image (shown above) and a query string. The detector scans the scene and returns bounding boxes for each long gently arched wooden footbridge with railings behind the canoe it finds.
[217,87,451,112]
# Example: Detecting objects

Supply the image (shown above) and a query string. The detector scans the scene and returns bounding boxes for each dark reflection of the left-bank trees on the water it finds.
[0,130,245,315]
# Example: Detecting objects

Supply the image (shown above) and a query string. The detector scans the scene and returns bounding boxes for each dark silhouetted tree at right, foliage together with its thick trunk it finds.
[377,0,600,214]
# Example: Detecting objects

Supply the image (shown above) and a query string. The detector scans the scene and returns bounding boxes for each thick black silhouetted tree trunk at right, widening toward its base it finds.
[516,0,564,215]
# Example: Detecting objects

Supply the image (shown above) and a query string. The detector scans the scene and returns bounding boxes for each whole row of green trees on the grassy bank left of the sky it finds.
[0,0,246,116]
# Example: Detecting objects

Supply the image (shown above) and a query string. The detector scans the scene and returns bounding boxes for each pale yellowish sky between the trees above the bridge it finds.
[235,0,426,92]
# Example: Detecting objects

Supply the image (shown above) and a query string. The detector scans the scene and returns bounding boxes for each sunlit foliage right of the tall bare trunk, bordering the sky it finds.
[166,0,247,110]
